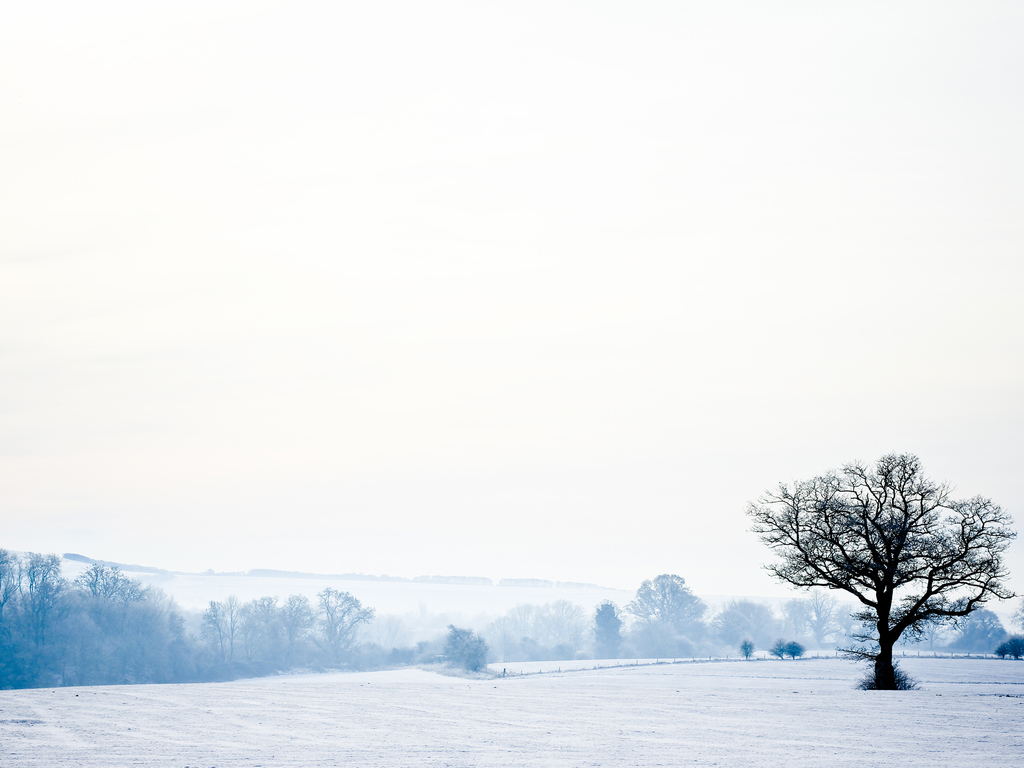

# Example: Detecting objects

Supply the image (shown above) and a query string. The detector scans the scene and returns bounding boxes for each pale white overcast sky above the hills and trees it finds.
[0,0,1024,595]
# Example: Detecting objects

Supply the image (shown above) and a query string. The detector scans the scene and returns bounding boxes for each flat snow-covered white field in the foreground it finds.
[0,658,1024,768]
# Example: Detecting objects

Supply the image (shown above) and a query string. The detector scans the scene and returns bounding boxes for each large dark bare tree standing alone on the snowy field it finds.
[748,454,1016,690]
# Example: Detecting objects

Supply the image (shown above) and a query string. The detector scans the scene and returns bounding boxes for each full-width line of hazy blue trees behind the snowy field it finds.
[0,549,1024,688]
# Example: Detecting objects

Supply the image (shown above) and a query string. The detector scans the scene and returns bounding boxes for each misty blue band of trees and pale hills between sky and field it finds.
[0,549,1024,688]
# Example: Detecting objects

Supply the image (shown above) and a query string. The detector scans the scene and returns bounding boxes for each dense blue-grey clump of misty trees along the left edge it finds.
[0,549,380,688]
